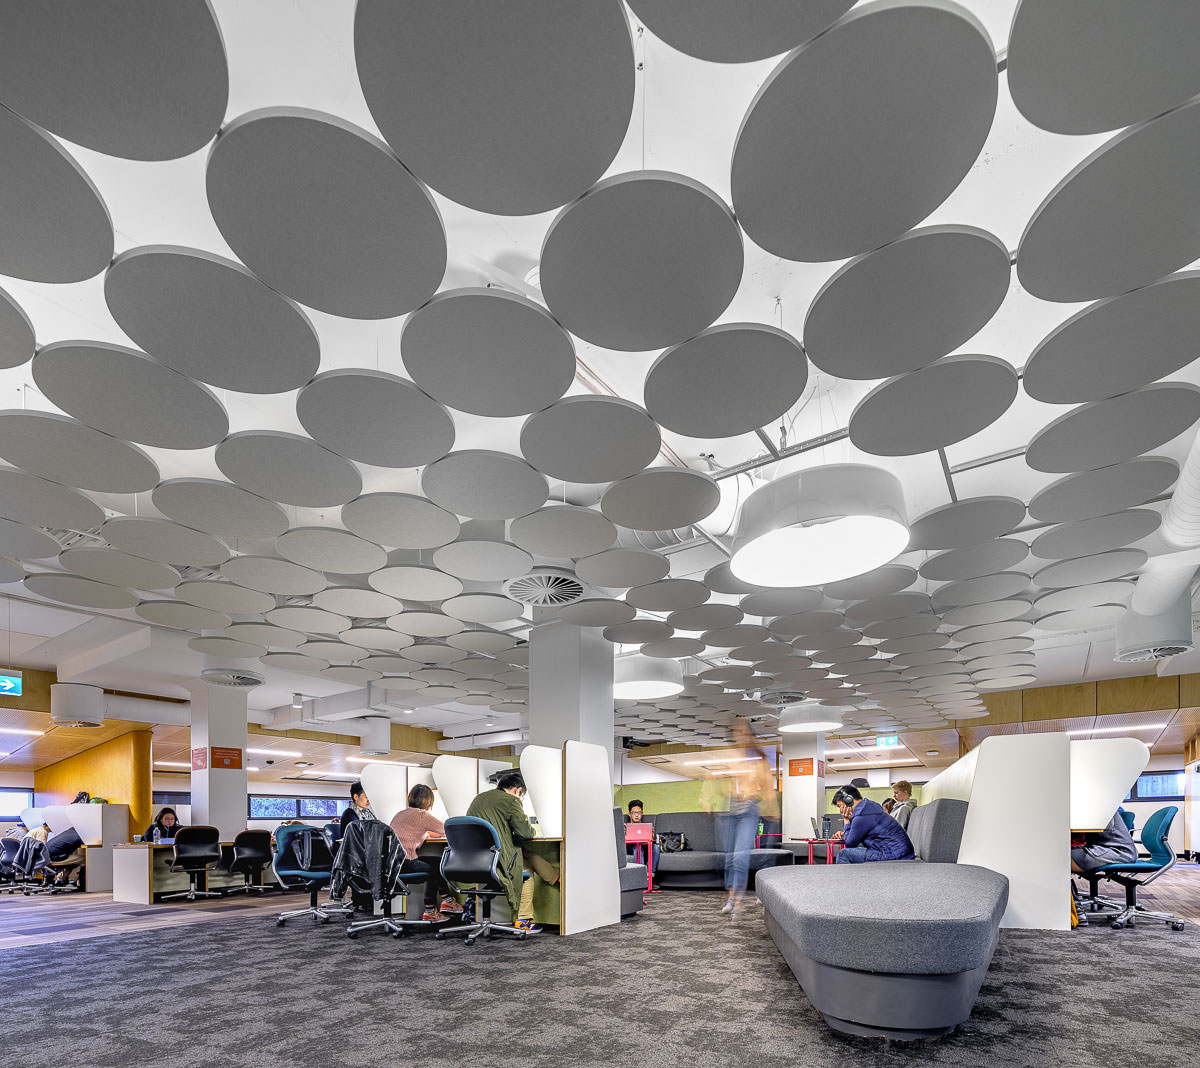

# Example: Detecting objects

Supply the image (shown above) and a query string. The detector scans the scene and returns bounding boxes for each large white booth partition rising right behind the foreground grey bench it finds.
[922,733,1070,930]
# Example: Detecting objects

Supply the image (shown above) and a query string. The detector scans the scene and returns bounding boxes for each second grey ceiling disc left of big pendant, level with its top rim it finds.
[421,449,550,520]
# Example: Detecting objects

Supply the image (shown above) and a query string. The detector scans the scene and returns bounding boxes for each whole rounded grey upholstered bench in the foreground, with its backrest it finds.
[757,799,1008,1039]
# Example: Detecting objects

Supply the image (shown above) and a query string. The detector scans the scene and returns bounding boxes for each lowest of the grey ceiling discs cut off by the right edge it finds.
[1025,379,1200,473]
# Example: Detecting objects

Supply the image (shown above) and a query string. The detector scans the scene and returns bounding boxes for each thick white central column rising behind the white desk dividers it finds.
[529,623,614,779]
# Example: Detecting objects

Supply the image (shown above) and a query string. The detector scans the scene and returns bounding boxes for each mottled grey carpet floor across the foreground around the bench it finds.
[0,892,1200,1068]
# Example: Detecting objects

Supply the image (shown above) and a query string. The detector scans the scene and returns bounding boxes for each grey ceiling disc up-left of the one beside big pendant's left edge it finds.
[521,395,662,482]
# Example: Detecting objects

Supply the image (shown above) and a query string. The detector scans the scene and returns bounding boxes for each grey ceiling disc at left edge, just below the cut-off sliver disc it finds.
[0,410,158,493]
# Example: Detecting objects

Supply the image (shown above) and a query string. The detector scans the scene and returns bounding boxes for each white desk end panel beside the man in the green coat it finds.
[562,742,620,935]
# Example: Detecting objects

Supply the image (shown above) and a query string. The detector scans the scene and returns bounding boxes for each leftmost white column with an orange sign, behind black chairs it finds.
[190,683,246,841]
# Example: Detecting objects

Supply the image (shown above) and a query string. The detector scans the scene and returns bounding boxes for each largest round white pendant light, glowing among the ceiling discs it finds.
[730,463,908,587]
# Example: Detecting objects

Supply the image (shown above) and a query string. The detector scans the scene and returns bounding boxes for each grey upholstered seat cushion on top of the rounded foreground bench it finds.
[757,863,1008,974]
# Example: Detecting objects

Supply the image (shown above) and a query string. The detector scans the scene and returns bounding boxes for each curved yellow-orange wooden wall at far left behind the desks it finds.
[34,728,154,834]
